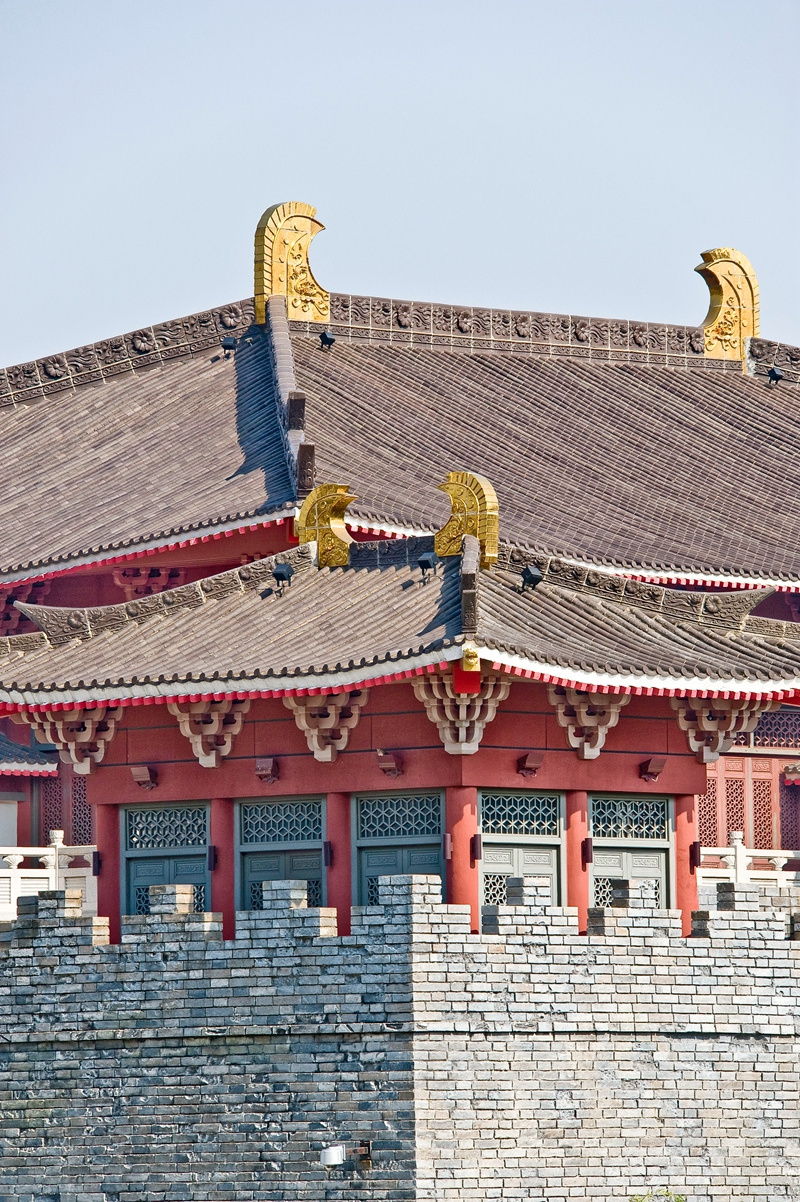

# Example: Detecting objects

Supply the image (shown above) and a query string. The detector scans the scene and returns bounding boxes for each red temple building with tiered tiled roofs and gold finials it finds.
[0,203,800,938]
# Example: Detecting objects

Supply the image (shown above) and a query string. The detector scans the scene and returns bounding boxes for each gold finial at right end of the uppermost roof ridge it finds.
[694,246,759,362]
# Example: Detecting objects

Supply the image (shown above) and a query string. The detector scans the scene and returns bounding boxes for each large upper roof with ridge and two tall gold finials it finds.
[0,203,800,587]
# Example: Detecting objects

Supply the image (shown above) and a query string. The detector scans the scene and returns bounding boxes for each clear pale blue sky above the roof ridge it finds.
[0,0,800,364]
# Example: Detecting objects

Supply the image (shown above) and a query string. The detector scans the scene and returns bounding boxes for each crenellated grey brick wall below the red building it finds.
[0,877,800,1202]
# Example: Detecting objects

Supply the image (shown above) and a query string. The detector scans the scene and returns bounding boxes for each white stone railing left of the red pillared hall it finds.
[0,831,97,922]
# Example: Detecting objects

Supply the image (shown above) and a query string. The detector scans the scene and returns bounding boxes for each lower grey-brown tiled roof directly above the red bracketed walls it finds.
[0,538,800,707]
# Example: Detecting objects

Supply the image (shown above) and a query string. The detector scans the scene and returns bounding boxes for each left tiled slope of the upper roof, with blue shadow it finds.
[0,307,294,576]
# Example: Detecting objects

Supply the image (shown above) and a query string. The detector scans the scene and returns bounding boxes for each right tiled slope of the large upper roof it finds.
[293,322,800,581]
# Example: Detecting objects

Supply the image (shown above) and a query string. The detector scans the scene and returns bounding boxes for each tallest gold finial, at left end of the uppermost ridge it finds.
[255,201,330,325]
